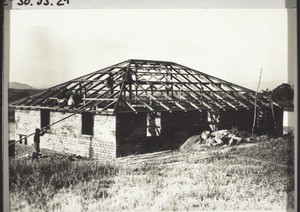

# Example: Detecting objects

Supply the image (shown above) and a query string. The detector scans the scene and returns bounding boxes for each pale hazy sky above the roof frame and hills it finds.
[9,9,296,90]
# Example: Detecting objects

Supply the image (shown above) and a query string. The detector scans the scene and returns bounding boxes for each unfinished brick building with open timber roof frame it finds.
[11,60,283,159]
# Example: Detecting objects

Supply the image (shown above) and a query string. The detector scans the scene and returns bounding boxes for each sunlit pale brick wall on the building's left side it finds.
[15,110,116,159]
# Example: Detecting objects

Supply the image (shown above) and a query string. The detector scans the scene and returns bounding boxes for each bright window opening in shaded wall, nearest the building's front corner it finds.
[147,112,161,137]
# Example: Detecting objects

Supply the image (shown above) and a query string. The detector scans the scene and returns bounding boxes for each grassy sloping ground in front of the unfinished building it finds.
[10,137,294,211]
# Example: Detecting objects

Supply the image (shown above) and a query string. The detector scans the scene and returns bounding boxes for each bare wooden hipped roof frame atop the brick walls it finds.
[10,59,279,114]
